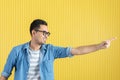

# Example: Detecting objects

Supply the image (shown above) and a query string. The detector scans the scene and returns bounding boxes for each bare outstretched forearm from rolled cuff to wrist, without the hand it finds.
[72,44,101,55]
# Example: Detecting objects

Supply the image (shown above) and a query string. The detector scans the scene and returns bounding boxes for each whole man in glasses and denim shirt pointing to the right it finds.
[0,19,115,80]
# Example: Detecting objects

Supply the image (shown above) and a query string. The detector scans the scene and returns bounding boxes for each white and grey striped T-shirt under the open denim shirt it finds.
[27,48,40,80]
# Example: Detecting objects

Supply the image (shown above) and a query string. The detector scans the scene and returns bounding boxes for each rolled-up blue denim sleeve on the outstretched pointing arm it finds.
[53,46,73,59]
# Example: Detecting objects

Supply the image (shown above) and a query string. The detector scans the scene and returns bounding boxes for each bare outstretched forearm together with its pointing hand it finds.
[71,38,116,55]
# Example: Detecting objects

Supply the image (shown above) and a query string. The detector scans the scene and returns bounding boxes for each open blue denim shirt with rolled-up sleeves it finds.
[2,42,73,80]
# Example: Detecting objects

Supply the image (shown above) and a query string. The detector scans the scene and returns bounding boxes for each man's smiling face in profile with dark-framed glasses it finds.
[32,25,49,45]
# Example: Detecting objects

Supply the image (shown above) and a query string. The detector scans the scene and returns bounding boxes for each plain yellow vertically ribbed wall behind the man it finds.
[0,0,120,80]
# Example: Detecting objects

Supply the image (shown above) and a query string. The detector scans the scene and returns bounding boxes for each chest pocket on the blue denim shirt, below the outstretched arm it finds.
[42,60,53,73]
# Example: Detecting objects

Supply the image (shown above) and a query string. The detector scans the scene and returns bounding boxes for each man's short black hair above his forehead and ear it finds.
[30,19,47,35]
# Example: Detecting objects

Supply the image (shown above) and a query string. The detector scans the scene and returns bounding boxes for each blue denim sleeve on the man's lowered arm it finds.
[1,48,16,78]
